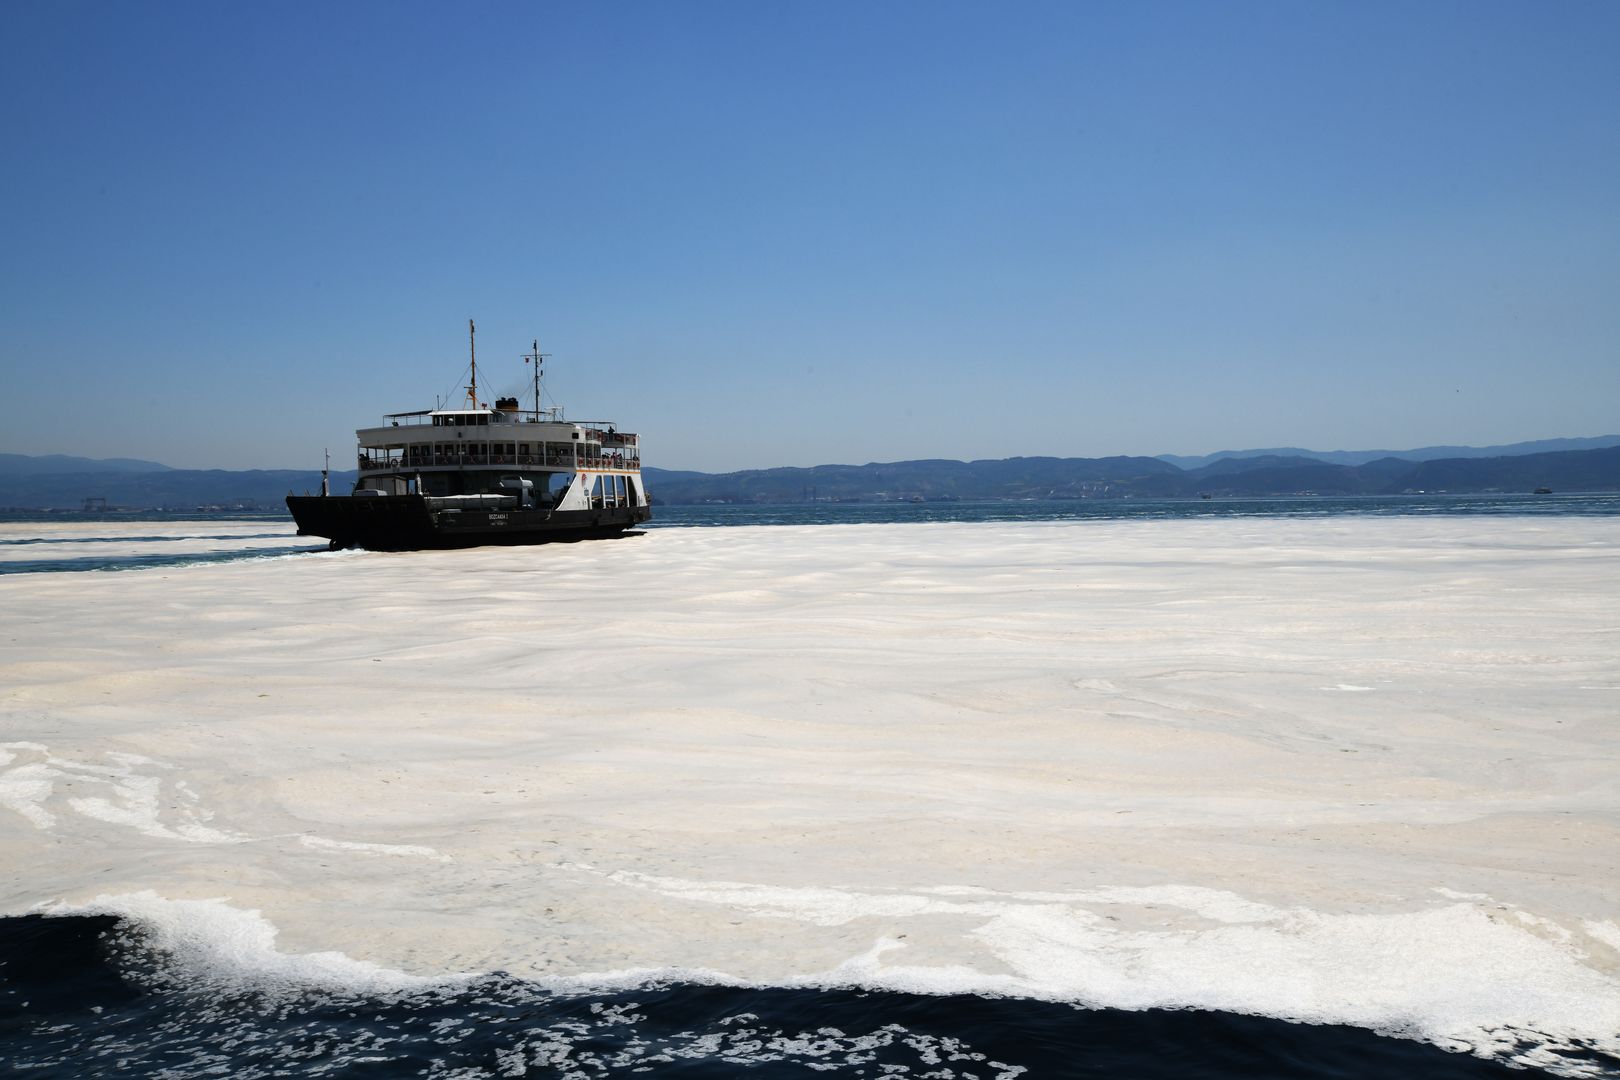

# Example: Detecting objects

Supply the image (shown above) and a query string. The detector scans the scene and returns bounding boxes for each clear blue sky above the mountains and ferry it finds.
[0,0,1620,471]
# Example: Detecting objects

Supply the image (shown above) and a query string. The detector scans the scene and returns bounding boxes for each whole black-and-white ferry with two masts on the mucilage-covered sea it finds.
[287,319,653,551]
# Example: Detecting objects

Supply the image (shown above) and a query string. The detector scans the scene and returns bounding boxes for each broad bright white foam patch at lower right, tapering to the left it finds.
[559,865,1620,1059]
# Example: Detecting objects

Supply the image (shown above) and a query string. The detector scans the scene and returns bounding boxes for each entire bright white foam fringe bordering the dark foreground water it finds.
[42,865,1620,1075]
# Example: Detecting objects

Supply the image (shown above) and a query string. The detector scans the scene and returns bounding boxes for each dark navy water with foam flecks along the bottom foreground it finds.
[0,915,1594,1080]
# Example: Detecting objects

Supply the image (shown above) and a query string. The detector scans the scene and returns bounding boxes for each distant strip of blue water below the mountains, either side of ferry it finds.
[0,494,1620,575]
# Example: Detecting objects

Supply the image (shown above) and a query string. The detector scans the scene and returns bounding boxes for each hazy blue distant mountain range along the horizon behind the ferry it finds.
[0,436,1620,510]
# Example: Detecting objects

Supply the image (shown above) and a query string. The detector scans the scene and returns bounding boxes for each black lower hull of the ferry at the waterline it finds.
[287,495,653,551]
